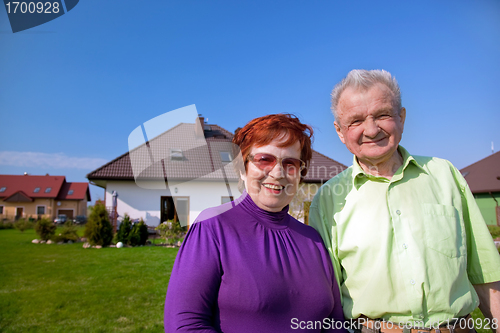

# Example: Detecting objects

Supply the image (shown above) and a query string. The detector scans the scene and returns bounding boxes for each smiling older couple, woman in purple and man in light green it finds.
[164,70,500,333]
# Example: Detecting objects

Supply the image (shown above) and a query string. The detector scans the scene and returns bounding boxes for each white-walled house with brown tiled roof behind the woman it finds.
[87,117,346,226]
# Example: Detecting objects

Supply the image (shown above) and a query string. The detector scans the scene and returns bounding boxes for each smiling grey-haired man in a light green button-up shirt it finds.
[310,70,500,333]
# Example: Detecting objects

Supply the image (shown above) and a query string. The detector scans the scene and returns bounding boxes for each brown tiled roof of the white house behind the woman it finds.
[87,123,347,182]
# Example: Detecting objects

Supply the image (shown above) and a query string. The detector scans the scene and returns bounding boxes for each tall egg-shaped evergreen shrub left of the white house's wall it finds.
[84,202,113,246]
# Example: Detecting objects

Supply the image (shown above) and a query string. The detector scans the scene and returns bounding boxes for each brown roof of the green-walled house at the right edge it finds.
[460,152,500,193]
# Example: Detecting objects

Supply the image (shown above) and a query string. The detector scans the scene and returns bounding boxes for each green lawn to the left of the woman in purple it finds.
[0,229,177,333]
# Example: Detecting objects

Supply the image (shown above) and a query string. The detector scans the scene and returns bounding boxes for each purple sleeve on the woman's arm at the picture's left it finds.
[164,222,222,333]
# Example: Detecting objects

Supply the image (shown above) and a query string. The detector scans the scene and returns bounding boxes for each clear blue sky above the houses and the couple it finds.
[0,0,500,204]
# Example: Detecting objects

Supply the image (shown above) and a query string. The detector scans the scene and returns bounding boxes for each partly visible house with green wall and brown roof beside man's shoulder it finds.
[460,152,500,225]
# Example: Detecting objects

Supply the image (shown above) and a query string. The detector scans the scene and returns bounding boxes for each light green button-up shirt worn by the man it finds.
[309,146,500,327]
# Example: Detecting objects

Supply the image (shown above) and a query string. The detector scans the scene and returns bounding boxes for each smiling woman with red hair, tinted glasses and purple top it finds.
[164,114,344,333]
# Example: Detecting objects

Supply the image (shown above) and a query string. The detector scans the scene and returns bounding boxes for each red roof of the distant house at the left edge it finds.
[0,175,90,201]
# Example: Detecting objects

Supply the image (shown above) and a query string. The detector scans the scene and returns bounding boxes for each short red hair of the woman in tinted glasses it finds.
[233,113,313,181]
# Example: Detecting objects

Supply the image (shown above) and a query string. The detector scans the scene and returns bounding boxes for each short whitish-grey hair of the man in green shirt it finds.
[332,69,402,120]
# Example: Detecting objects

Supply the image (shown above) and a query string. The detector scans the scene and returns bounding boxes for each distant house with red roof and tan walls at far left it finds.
[0,174,90,220]
